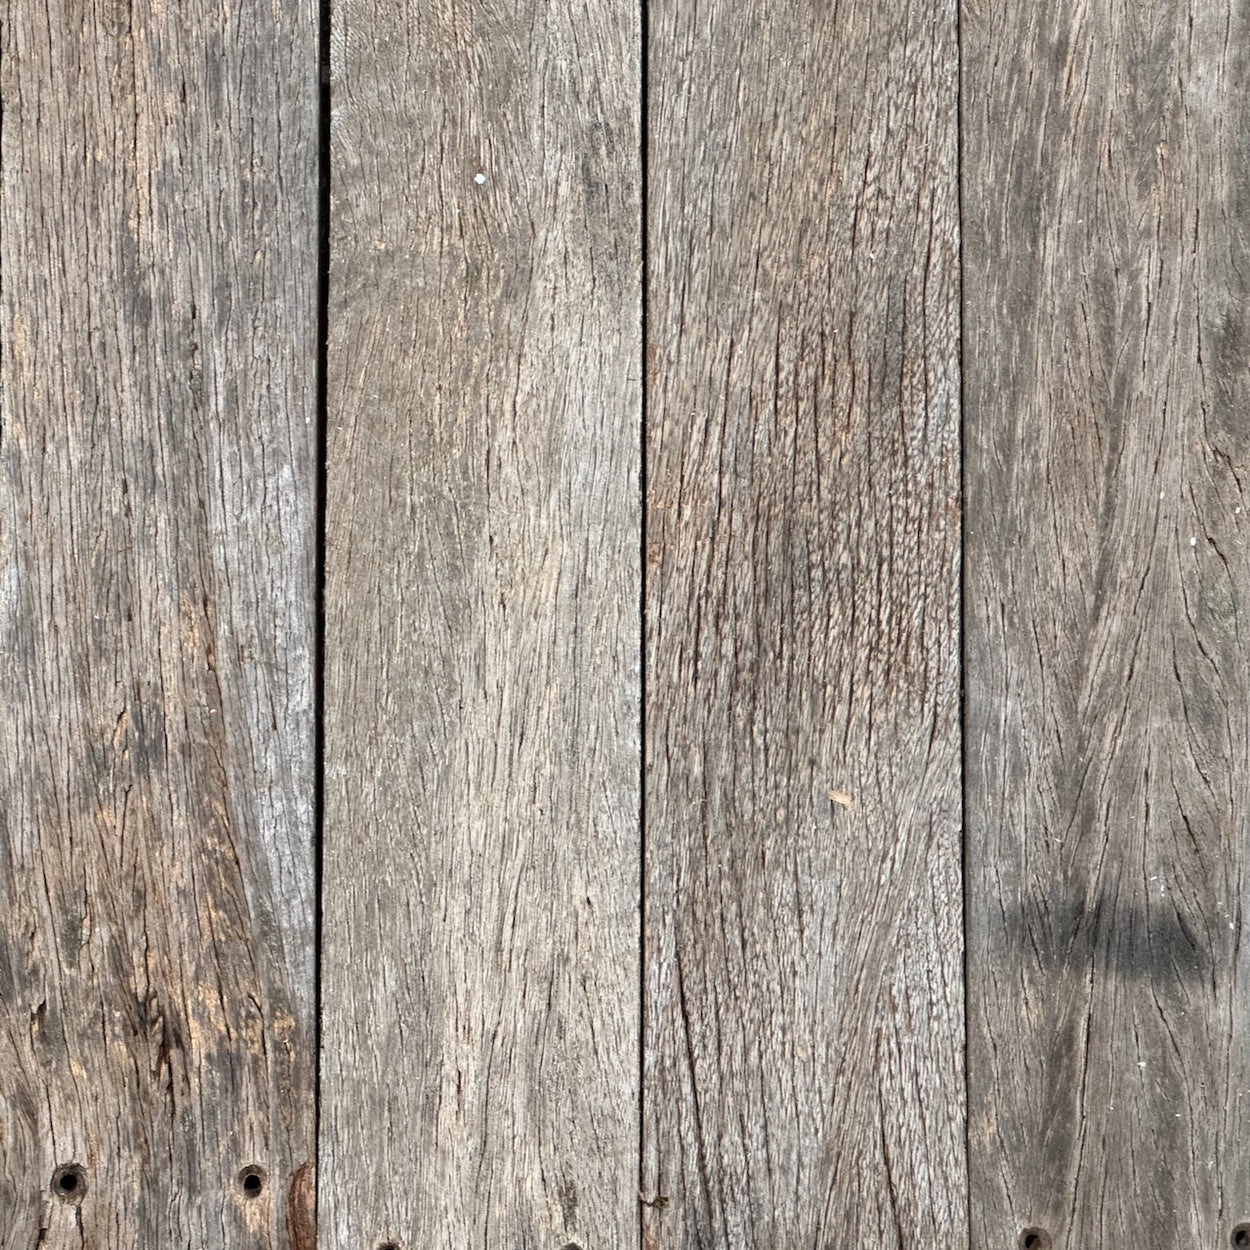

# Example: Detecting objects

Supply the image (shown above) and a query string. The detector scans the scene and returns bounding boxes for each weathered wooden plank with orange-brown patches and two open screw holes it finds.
[0,0,316,1250]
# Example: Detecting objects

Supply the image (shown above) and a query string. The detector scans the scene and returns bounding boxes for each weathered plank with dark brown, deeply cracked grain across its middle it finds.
[644,0,966,1250]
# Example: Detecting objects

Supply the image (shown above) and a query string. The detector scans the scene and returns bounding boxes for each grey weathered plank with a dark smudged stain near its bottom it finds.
[964,0,1250,1250]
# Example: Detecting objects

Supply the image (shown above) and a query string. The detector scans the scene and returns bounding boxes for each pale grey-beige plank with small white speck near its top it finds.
[321,0,641,1250]
